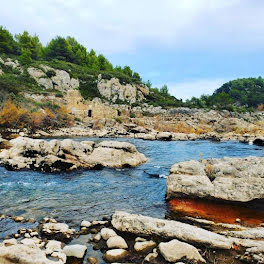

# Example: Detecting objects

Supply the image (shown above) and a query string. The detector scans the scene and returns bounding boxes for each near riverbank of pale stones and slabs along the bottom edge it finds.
[0,211,264,264]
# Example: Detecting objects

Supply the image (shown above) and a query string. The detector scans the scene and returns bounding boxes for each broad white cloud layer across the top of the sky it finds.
[0,0,264,53]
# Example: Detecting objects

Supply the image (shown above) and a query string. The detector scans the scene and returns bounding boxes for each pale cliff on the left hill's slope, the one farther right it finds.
[97,75,149,104]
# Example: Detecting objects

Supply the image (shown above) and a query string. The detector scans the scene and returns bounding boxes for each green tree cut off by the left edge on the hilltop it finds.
[0,26,18,55]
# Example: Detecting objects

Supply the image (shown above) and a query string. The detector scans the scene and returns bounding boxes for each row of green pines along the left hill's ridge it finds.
[0,26,142,82]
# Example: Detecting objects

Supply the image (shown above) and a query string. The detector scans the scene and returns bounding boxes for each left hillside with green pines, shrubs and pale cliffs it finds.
[0,27,181,107]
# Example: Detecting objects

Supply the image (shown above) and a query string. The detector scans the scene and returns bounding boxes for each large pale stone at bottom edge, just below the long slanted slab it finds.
[159,239,206,263]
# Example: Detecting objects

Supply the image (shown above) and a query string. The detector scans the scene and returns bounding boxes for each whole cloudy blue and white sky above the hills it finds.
[0,0,264,100]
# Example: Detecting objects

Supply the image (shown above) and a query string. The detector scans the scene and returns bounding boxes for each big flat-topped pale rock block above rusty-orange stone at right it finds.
[166,157,264,202]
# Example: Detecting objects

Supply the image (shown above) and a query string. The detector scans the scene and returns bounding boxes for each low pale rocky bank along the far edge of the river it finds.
[30,124,264,146]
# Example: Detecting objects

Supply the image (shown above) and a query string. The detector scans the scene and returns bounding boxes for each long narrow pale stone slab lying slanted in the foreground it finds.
[112,211,233,249]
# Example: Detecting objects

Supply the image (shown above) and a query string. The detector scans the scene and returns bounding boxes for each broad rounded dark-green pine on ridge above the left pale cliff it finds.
[45,37,73,62]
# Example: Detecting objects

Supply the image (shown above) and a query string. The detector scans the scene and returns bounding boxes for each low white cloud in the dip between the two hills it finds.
[164,78,230,100]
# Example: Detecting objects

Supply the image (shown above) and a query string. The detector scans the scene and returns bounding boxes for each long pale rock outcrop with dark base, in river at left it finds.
[0,137,147,172]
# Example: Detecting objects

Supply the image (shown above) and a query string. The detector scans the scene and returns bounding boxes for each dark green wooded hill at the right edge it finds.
[186,77,264,112]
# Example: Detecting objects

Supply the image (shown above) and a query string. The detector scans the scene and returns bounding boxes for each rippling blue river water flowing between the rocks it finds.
[0,138,264,229]
